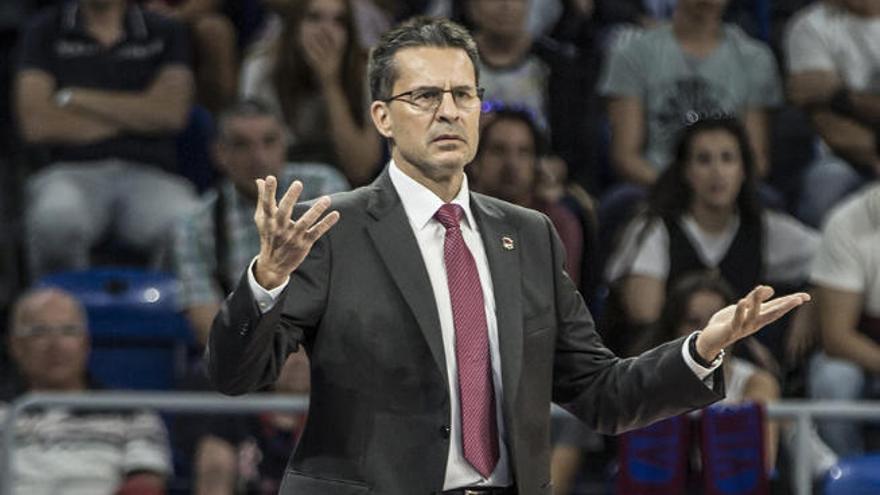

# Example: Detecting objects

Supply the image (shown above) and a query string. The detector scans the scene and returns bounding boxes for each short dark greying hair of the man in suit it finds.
[367,16,480,101]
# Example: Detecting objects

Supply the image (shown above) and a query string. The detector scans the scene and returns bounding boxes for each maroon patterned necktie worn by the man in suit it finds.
[434,204,498,478]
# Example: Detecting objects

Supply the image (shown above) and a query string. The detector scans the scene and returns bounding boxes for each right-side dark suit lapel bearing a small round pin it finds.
[471,194,523,418]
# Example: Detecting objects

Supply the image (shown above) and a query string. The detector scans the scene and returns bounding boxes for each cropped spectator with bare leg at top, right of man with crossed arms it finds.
[144,0,238,112]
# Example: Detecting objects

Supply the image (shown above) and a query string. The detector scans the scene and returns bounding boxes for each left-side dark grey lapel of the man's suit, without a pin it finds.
[367,169,446,377]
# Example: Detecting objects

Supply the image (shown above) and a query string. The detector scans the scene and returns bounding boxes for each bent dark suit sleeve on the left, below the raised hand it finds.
[205,231,330,395]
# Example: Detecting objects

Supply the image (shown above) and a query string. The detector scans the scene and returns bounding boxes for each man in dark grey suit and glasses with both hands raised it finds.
[207,18,808,495]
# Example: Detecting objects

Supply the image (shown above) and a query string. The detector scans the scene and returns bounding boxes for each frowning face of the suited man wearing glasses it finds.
[371,47,480,182]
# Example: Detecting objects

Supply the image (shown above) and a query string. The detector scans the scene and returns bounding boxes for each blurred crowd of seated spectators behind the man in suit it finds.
[0,0,880,494]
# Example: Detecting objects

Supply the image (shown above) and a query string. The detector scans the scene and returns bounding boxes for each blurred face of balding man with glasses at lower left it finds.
[10,293,89,390]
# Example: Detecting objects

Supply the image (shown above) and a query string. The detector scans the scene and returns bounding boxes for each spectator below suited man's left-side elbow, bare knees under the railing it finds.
[175,350,310,495]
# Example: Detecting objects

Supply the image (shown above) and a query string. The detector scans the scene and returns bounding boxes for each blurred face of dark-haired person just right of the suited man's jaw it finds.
[471,119,537,206]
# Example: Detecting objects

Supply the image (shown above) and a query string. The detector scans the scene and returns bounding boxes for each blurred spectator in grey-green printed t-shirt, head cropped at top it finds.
[599,0,782,186]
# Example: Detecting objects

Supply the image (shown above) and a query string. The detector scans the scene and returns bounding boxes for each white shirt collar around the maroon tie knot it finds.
[388,160,477,230]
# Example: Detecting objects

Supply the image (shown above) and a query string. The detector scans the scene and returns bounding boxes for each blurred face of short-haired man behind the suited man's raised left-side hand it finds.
[215,116,286,198]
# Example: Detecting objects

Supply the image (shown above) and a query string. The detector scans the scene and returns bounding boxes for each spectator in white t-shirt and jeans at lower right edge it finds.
[809,183,880,456]
